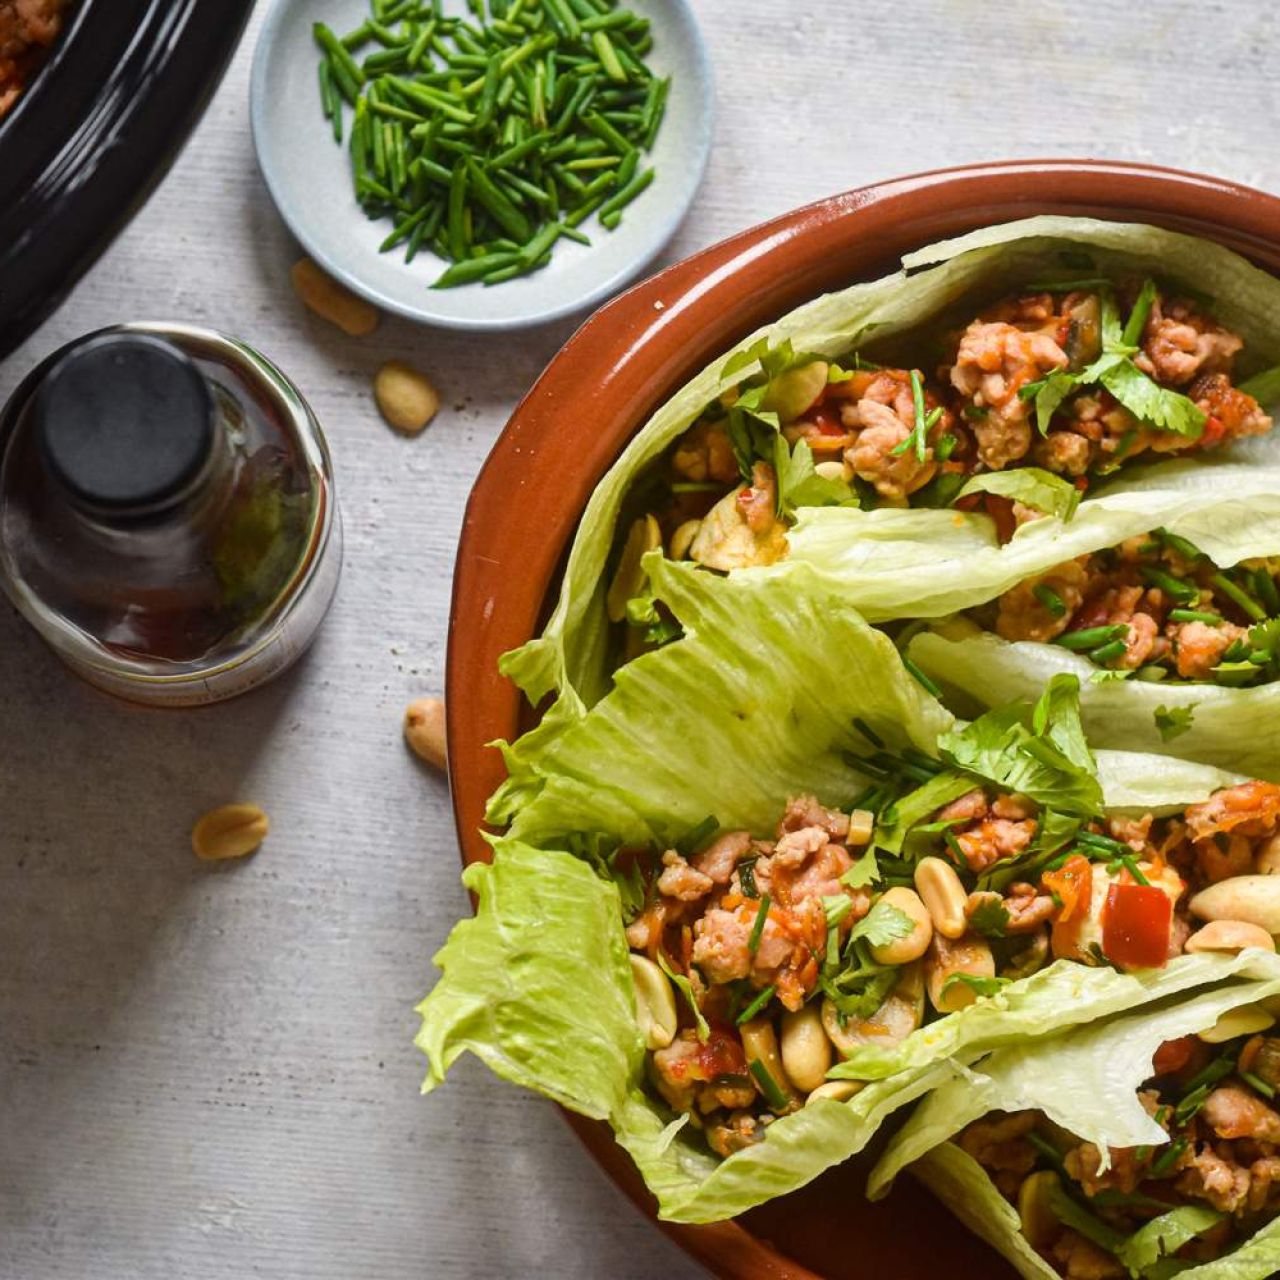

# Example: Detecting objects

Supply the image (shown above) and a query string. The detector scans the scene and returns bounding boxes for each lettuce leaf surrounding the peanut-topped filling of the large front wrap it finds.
[417,557,1269,1222]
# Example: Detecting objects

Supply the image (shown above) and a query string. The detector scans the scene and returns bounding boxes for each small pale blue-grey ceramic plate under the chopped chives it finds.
[250,0,713,330]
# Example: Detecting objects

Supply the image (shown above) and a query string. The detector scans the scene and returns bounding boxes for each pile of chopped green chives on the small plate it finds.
[312,0,671,288]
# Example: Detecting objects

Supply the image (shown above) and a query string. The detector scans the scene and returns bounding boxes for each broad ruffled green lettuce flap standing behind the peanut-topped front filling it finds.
[494,554,951,845]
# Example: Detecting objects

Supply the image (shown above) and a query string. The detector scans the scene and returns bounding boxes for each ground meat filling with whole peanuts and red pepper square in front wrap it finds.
[626,773,1280,1157]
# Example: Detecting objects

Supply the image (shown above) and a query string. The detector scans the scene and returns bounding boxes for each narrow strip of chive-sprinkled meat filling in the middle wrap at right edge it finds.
[970,530,1280,686]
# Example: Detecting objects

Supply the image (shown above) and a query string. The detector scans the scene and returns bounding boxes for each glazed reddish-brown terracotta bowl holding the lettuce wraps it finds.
[448,160,1280,1280]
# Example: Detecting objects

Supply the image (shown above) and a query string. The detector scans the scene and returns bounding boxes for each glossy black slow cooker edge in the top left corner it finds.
[0,0,253,356]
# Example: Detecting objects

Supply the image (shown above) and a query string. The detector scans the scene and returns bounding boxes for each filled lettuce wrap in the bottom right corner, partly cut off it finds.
[868,950,1280,1280]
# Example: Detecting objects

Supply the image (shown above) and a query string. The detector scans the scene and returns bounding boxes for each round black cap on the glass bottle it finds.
[32,333,216,517]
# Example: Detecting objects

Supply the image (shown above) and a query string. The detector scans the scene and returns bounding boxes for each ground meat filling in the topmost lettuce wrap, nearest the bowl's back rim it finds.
[655,282,1272,586]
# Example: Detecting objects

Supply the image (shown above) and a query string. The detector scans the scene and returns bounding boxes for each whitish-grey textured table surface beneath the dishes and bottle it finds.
[0,0,1280,1280]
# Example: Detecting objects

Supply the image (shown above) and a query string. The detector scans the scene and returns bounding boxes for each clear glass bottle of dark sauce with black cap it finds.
[0,324,342,705]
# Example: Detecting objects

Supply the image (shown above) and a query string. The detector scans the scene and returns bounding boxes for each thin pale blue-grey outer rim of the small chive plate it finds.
[250,0,716,333]
